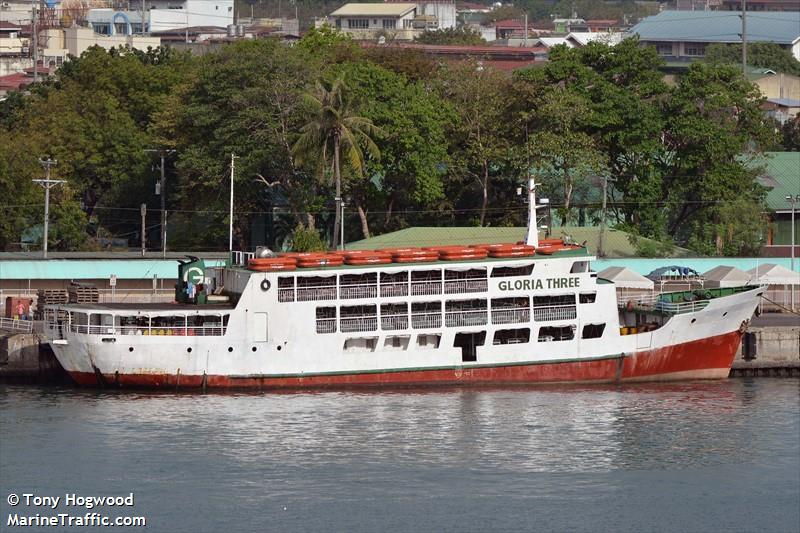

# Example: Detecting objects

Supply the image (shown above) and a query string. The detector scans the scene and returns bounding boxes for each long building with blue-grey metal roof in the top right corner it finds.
[631,11,800,60]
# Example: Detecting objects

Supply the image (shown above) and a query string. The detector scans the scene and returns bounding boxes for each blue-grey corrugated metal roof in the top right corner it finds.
[631,11,800,44]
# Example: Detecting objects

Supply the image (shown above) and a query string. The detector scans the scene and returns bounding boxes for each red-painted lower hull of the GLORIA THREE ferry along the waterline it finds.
[69,331,741,389]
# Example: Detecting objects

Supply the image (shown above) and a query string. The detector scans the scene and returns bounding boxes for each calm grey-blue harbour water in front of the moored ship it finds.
[0,378,800,532]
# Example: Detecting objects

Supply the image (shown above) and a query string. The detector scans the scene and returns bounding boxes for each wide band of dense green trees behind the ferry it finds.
[0,35,780,254]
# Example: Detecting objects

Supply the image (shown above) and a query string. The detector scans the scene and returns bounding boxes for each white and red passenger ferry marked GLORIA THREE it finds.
[45,180,763,389]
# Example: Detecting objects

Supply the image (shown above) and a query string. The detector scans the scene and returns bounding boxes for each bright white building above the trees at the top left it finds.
[88,0,234,35]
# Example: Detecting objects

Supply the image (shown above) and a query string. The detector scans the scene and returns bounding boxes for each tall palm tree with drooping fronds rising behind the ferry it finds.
[292,78,380,248]
